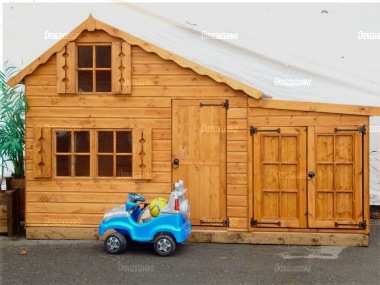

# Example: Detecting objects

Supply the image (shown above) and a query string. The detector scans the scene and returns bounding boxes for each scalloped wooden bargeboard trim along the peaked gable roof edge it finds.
[8,14,262,99]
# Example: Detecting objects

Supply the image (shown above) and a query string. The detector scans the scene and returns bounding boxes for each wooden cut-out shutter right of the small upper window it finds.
[112,42,132,94]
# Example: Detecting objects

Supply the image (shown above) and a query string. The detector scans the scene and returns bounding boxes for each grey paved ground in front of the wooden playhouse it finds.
[0,220,380,285]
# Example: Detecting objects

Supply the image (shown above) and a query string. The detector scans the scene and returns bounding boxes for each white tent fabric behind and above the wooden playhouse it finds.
[3,3,380,202]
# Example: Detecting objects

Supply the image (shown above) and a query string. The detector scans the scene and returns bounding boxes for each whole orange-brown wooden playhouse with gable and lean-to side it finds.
[9,16,380,246]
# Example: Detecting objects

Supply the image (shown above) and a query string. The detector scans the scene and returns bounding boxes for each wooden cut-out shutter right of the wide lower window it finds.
[132,128,153,180]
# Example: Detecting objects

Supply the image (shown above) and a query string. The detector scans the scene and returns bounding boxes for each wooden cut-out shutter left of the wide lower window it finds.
[33,128,52,178]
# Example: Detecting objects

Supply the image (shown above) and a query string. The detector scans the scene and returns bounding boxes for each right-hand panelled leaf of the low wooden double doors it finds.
[308,126,363,229]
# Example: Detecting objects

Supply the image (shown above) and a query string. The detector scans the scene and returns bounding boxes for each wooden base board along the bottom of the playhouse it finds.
[26,227,369,246]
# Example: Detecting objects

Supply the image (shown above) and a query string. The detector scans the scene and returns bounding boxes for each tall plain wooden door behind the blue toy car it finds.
[172,100,227,225]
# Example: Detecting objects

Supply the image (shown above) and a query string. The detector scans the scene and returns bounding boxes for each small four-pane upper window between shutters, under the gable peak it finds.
[77,45,112,93]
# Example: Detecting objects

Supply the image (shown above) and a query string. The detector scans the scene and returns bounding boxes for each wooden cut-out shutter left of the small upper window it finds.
[57,42,76,94]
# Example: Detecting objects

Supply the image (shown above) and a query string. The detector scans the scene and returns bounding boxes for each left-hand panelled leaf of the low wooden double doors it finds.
[251,127,307,228]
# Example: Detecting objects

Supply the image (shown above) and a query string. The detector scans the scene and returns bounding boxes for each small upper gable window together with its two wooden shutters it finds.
[57,31,131,94]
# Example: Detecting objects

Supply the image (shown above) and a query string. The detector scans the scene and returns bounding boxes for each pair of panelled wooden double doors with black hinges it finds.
[251,126,365,229]
